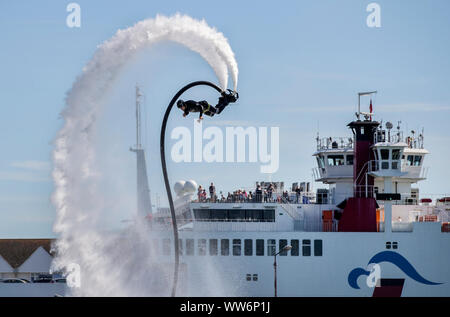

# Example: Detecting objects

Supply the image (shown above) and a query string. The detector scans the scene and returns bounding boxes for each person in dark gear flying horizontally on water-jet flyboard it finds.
[177,89,239,122]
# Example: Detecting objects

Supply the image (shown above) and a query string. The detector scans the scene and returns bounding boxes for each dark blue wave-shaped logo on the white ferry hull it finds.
[348,251,442,289]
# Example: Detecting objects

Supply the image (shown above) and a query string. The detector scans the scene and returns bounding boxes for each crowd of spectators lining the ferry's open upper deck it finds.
[197,183,301,203]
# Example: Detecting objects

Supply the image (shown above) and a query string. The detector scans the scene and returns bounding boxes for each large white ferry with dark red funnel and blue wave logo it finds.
[143,92,450,297]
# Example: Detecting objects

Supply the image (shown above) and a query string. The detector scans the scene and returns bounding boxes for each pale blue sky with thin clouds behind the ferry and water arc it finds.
[0,0,450,238]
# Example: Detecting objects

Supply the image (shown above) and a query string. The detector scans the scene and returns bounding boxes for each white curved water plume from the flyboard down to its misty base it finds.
[52,14,238,296]
